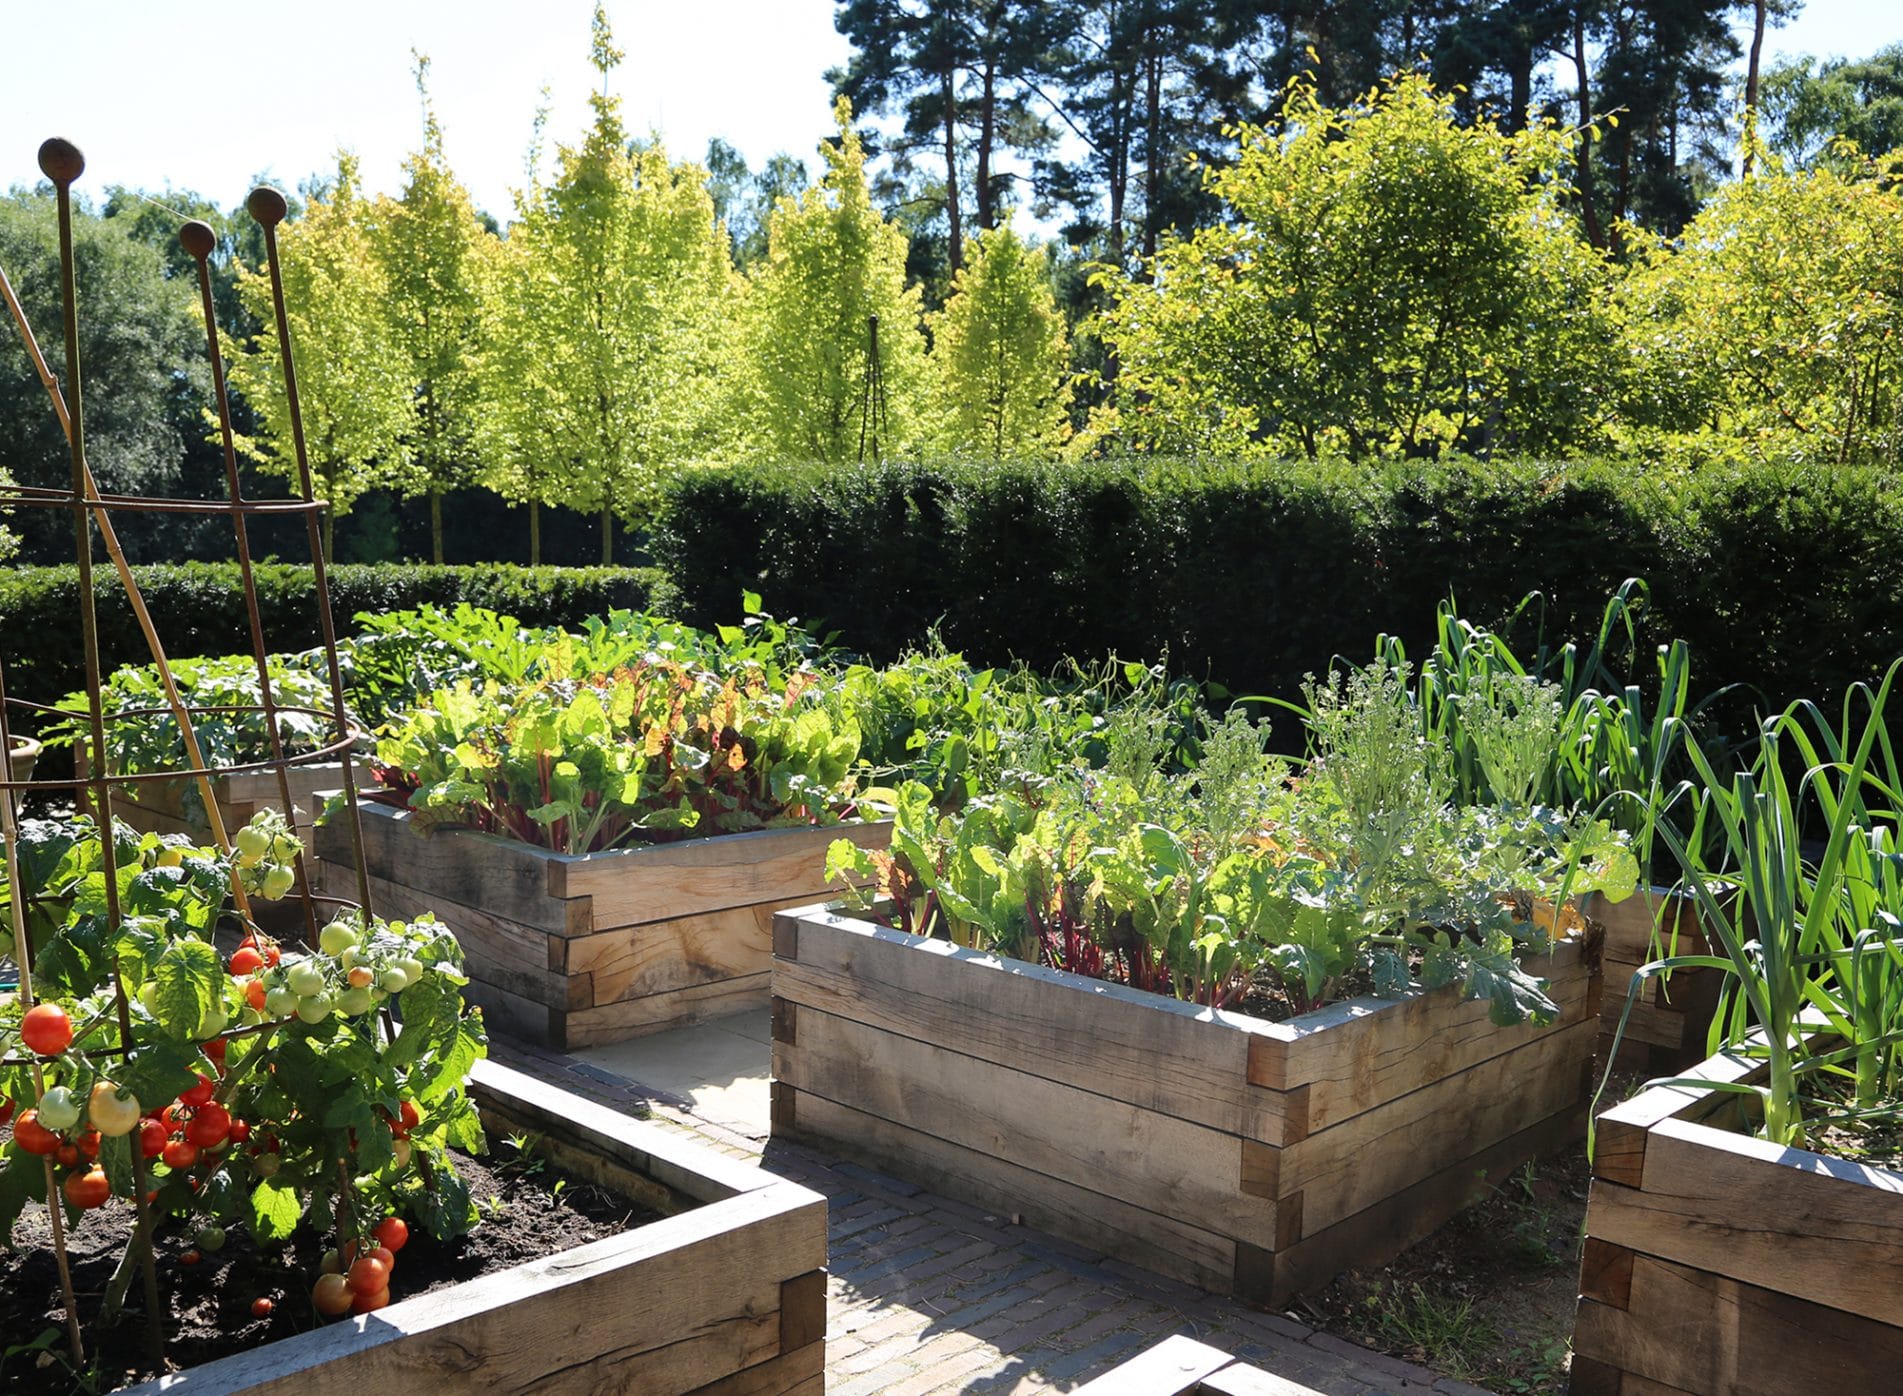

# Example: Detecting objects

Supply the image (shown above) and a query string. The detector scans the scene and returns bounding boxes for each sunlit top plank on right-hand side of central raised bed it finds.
[1248,940,1597,1132]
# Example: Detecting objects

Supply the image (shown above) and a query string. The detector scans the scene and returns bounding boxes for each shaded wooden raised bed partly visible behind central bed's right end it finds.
[1585,886,1724,1076]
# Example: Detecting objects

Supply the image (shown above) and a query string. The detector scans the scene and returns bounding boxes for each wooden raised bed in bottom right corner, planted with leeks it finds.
[1572,1056,1903,1396]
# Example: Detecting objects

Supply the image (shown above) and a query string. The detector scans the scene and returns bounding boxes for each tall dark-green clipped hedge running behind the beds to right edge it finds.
[655,458,1903,713]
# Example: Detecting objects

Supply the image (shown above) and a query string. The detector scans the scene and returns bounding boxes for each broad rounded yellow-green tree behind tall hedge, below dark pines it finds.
[1092,74,1616,456]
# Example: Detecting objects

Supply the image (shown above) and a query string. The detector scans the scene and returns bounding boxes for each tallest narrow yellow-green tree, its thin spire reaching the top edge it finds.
[485,6,735,563]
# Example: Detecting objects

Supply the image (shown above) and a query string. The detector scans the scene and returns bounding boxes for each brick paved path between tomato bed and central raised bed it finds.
[489,1037,1488,1396]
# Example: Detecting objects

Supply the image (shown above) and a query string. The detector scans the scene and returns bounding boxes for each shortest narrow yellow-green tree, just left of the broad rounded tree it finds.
[931,215,1069,458]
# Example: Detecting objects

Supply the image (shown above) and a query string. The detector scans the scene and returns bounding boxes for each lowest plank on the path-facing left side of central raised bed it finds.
[775,1084,1235,1289]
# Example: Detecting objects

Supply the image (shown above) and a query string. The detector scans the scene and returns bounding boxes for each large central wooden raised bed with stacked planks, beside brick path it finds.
[773,907,1599,1305]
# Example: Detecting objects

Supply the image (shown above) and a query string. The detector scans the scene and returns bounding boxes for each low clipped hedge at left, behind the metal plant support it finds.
[0,563,670,730]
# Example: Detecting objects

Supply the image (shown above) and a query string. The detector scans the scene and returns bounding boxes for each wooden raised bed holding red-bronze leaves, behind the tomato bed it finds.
[318,803,891,1050]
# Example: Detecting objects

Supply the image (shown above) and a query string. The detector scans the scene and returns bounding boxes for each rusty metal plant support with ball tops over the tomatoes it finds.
[0,139,373,1362]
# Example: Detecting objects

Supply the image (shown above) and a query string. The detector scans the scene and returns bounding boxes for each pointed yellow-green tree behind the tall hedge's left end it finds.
[736,97,929,469]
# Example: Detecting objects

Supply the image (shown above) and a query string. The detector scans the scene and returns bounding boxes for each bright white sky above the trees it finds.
[0,0,1903,221]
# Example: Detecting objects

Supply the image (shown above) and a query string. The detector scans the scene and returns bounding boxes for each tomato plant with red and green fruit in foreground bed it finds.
[0,812,487,1354]
